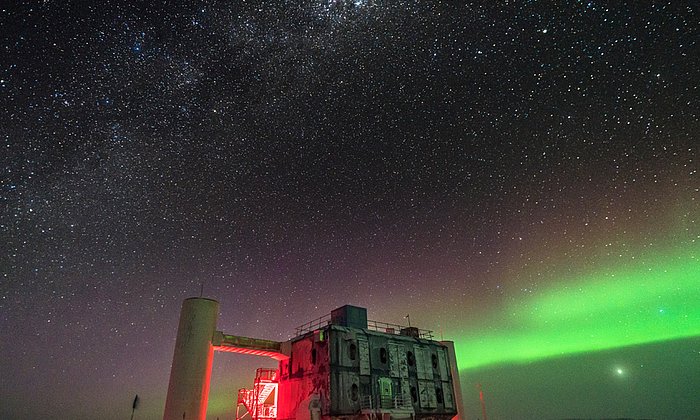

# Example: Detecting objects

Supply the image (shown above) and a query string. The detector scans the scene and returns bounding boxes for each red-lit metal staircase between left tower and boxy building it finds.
[236,368,278,420]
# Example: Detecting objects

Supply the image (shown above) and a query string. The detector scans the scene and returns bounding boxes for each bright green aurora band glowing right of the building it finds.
[455,245,700,370]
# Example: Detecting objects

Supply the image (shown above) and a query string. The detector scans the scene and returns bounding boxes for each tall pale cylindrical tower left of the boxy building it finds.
[163,298,219,420]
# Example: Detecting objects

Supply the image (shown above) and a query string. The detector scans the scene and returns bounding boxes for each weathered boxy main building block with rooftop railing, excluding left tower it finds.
[268,305,457,420]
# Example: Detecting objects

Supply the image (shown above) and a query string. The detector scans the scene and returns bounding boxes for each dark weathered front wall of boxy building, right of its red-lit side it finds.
[324,326,456,420]
